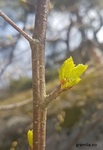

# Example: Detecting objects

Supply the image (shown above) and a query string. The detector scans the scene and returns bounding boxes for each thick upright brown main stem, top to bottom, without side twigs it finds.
[30,0,48,150]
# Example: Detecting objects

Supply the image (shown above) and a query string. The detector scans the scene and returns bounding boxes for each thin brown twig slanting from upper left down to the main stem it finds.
[0,10,32,42]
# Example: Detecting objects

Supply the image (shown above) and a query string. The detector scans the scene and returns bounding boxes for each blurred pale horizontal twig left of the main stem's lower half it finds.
[0,98,32,110]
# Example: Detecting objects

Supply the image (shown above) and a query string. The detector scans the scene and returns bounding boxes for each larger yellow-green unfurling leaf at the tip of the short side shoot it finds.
[59,57,88,89]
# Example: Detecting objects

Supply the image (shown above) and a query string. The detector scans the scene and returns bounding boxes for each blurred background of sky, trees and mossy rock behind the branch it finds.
[0,0,103,150]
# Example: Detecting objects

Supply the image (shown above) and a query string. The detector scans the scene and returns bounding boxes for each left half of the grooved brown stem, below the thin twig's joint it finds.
[30,41,40,150]
